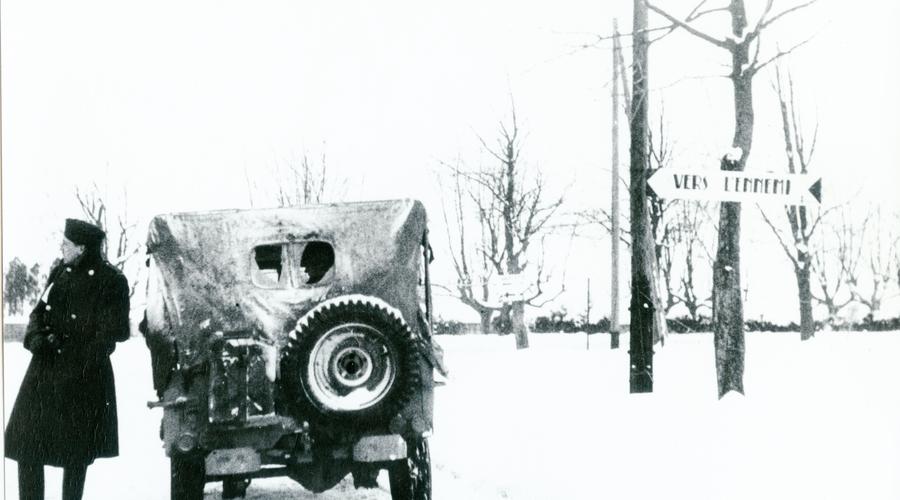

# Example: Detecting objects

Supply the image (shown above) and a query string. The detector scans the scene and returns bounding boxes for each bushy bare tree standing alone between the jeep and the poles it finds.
[445,105,563,349]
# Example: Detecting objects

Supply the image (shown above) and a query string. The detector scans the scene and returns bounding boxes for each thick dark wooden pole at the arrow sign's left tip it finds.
[628,0,656,393]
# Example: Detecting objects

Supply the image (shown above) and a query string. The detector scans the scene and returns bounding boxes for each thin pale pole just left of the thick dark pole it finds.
[609,19,622,349]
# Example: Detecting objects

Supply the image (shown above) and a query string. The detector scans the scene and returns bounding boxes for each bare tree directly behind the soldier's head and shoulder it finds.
[75,184,143,296]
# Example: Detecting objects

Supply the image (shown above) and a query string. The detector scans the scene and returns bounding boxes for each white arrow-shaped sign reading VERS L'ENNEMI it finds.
[647,168,822,205]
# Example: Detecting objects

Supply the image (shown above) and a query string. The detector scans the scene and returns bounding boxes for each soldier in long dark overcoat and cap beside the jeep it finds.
[5,219,129,500]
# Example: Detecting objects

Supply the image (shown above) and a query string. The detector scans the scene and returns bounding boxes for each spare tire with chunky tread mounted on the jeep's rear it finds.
[281,296,419,424]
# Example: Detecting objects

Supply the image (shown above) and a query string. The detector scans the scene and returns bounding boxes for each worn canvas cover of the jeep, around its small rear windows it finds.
[146,200,426,372]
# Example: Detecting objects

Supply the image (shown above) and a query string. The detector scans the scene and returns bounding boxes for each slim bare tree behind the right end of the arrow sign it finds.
[760,64,827,340]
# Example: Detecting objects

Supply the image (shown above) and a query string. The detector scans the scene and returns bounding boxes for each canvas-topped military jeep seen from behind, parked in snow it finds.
[141,200,446,500]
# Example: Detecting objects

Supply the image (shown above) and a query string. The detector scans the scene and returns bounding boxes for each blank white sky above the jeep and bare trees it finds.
[0,0,900,318]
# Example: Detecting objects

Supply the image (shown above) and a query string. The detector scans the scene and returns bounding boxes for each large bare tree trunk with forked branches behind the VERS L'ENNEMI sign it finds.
[647,0,816,397]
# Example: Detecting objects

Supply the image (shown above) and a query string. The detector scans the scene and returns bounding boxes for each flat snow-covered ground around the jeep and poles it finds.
[4,332,900,500]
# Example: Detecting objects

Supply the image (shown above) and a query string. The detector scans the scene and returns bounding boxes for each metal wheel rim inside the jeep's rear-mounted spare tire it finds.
[306,323,397,411]
